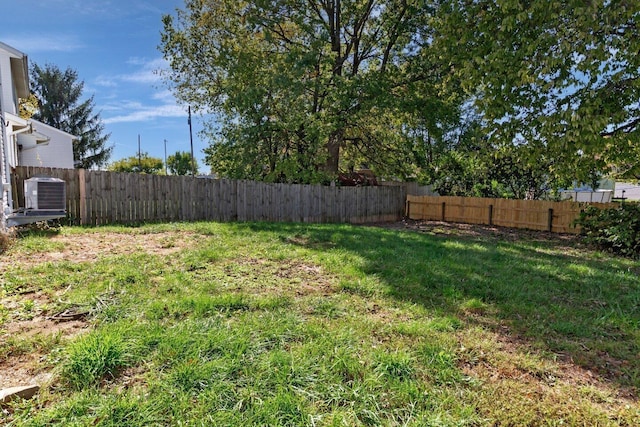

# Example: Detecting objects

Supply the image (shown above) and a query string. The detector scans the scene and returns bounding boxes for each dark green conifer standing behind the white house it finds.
[31,64,113,169]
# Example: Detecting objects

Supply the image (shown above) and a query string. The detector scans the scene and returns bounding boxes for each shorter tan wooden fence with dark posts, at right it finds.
[406,196,618,233]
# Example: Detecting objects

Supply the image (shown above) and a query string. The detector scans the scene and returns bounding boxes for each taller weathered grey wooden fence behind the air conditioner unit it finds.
[12,167,406,225]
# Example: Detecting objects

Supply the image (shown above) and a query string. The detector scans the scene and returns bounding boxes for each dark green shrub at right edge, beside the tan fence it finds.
[576,203,640,258]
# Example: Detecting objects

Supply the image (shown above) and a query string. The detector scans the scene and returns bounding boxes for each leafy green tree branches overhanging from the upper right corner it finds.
[433,0,640,186]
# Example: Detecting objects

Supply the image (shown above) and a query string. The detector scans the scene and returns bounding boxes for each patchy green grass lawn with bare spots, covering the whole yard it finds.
[0,223,640,426]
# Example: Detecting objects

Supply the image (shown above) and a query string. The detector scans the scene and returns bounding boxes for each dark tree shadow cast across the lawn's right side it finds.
[238,223,640,396]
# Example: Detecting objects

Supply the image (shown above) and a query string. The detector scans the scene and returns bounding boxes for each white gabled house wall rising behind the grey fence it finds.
[18,120,74,169]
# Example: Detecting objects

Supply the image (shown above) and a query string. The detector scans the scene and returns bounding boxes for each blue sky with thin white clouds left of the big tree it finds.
[0,0,208,172]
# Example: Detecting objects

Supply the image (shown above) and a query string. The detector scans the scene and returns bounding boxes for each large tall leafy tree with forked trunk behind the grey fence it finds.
[161,0,458,182]
